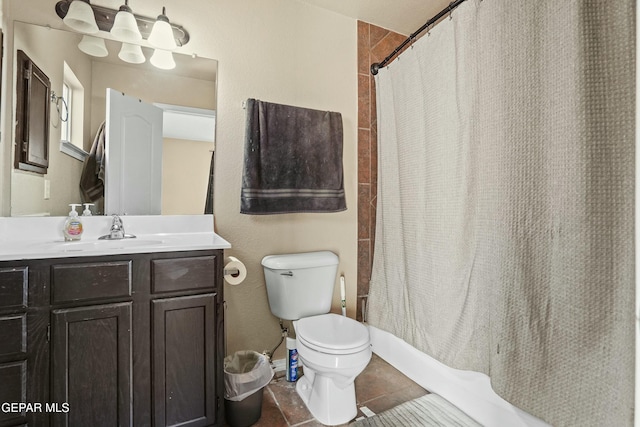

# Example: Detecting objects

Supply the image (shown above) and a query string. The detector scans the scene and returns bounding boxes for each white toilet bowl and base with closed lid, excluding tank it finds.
[294,313,371,425]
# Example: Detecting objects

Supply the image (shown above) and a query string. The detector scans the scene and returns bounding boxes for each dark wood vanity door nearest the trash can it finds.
[152,293,217,427]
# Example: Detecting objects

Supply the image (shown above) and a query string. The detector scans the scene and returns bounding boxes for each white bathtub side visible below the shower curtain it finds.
[369,325,550,427]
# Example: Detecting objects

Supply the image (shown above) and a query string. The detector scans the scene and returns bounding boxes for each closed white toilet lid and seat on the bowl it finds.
[296,313,369,354]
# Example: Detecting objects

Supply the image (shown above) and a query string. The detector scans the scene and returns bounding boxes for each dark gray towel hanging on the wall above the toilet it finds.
[240,99,346,215]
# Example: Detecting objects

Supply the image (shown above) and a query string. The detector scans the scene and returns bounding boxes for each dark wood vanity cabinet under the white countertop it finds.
[0,250,224,427]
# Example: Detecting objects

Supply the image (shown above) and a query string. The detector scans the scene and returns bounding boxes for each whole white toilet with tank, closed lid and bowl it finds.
[262,251,371,425]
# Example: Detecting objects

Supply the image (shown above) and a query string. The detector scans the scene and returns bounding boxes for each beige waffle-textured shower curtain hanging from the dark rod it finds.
[368,0,635,426]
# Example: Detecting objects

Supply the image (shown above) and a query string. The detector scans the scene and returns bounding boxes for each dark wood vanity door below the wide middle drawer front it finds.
[52,302,132,427]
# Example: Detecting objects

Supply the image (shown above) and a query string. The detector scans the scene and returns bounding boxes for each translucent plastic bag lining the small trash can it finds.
[224,350,273,402]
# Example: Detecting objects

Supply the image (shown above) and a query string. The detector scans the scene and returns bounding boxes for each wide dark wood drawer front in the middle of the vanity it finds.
[51,261,131,304]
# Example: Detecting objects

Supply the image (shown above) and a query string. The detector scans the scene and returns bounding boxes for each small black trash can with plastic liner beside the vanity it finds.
[224,350,273,427]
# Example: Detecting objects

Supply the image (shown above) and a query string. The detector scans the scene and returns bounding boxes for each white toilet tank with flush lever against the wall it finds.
[262,251,338,320]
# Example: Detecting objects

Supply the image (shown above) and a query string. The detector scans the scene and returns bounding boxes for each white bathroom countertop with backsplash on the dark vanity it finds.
[0,215,231,261]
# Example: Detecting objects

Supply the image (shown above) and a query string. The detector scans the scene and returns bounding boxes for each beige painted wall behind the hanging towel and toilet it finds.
[3,0,357,357]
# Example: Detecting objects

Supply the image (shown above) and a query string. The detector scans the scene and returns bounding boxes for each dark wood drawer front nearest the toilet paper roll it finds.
[151,255,216,293]
